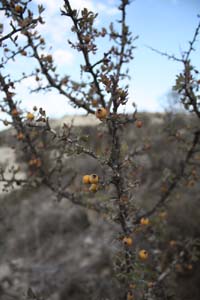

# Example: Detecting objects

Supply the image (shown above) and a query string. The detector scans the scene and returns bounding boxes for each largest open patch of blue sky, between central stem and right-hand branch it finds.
[128,0,200,111]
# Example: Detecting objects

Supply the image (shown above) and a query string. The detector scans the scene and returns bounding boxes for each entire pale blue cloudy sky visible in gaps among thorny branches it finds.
[0,0,200,126]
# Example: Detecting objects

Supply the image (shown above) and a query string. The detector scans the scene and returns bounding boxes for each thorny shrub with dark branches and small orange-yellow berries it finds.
[0,0,200,300]
